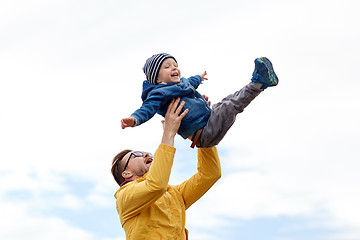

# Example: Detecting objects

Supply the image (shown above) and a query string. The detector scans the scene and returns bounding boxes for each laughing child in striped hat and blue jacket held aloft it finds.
[121,53,278,148]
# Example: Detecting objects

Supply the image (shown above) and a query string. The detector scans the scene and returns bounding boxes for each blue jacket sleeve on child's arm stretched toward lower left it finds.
[131,91,165,126]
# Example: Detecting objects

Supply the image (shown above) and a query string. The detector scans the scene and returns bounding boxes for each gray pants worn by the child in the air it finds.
[200,82,263,148]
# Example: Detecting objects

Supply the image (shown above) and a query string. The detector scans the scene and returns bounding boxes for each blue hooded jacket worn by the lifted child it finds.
[131,75,211,139]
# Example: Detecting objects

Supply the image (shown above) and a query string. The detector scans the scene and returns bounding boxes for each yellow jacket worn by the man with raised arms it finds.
[115,144,221,240]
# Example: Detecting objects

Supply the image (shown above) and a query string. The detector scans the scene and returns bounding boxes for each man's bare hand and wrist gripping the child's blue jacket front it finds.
[161,98,189,146]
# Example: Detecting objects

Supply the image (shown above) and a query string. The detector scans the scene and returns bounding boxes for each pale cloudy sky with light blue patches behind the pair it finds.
[0,0,360,240]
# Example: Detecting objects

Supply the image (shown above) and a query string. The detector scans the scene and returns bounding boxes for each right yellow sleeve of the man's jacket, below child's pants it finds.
[176,147,221,209]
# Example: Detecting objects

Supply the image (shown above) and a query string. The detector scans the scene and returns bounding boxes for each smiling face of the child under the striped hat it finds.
[156,58,181,83]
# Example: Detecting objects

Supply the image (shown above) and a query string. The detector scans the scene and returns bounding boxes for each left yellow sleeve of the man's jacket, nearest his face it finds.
[116,144,175,224]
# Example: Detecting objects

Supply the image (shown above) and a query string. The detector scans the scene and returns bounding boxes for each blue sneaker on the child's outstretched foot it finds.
[251,57,279,89]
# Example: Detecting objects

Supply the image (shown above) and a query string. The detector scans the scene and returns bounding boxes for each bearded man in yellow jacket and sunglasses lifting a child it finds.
[111,98,221,240]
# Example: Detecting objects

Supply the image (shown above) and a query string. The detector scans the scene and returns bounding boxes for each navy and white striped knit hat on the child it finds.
[143,53,176,85]
